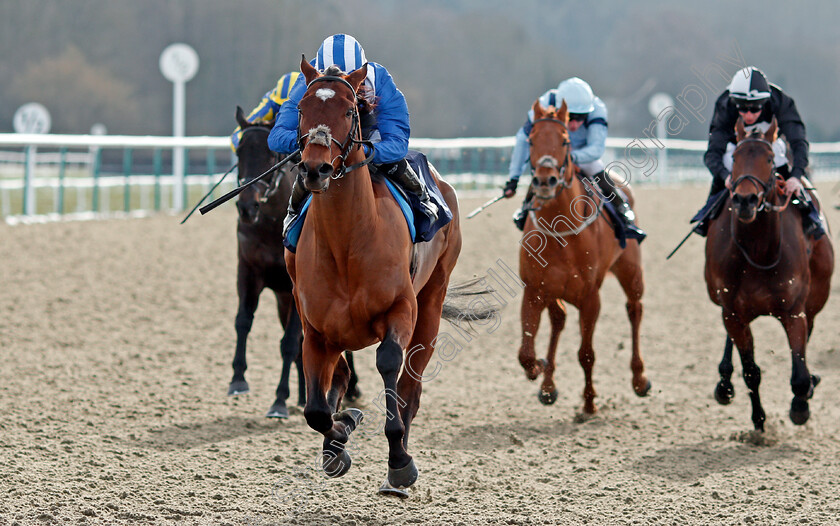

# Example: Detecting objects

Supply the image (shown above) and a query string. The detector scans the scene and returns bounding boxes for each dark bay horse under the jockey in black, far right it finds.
[705,118,834,431]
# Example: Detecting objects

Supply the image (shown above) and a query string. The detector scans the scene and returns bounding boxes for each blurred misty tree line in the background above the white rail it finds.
[0,0,840,141]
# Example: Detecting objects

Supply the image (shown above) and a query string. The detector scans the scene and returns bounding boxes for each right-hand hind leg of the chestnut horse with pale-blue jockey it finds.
[612,245,651,396]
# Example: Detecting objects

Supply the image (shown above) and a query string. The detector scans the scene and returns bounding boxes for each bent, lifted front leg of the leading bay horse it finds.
[303,326,362,477]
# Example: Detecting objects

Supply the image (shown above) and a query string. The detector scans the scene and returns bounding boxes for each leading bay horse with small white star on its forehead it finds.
[286,59,480,496]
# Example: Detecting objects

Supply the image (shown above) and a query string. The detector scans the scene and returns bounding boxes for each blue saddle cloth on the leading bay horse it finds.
[283,150,452,252]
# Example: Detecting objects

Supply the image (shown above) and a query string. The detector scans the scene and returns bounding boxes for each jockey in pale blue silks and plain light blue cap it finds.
[504,77,646,241]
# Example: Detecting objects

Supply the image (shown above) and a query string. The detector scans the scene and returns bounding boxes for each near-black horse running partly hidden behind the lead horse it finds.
[228,106,358,418]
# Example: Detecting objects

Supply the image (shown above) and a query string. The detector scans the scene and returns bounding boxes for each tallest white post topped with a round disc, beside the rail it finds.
[160,43,198,210]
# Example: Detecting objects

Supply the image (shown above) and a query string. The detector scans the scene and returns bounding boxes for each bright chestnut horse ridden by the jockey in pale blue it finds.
[519,100,651,415]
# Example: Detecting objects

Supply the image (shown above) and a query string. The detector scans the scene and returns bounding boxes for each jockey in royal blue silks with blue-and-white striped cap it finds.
[268,34,438,236]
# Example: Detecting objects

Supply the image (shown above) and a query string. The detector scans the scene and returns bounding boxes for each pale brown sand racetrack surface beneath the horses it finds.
[0,183,840,526]
